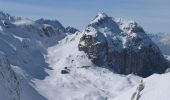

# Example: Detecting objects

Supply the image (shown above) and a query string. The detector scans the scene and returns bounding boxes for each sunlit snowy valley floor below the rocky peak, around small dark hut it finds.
[34,33,141,100]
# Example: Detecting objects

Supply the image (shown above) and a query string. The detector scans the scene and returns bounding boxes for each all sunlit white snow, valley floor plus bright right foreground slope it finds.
[34,33,170,100]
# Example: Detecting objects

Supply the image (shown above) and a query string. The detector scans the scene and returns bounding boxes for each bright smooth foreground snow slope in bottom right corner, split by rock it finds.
[112,73,170,100]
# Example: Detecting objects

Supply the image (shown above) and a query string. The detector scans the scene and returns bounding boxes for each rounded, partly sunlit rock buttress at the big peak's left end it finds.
[79,27,108,65]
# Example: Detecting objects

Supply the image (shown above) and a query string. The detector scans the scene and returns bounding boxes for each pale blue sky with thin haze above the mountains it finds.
[0,0,170,33]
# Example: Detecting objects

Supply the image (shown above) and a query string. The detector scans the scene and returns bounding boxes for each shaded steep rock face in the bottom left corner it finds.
[0,52,20,100]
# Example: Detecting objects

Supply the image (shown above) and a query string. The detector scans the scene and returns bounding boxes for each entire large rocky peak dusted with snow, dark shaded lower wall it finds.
[78,13,168,77]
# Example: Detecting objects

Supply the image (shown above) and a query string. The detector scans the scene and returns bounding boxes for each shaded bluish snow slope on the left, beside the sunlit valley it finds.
[0,12,66,100]
